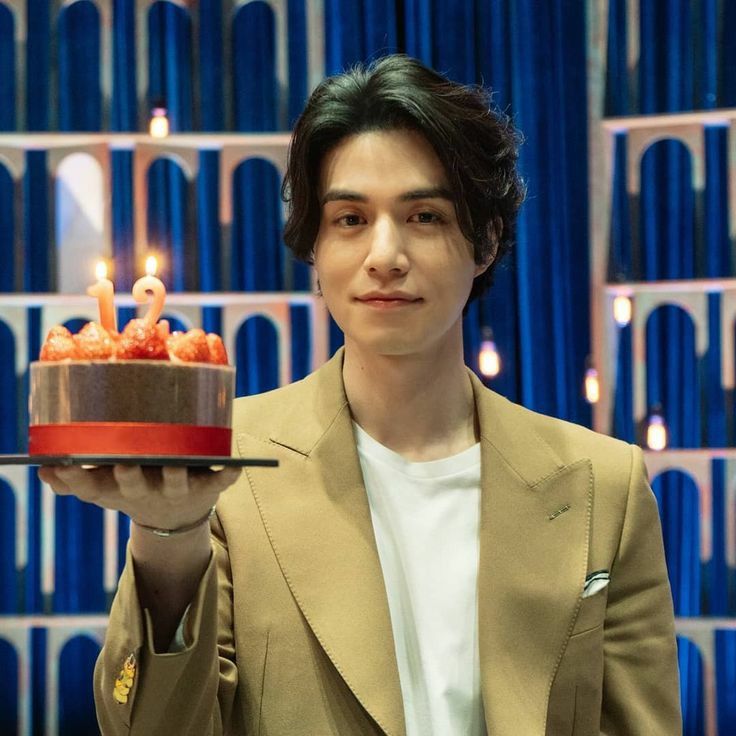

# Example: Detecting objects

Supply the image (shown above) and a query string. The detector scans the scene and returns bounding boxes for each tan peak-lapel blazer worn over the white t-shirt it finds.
[95,350,681,736]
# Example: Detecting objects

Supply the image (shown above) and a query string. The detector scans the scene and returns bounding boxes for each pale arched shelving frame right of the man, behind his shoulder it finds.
[586,0,736,736]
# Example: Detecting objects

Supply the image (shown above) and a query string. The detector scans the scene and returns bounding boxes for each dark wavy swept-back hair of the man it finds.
[281,54,525,313]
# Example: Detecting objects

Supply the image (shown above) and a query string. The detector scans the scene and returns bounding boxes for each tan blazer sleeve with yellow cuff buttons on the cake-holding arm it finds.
[94,518,244,736]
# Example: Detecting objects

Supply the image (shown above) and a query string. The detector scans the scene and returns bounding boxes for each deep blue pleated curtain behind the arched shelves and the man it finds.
[0,0,736,733]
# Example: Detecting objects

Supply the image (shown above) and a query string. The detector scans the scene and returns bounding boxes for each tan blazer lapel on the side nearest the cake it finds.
[239,384,405,736]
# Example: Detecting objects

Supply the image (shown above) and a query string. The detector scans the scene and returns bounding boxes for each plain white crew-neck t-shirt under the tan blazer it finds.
[353,422,486,736]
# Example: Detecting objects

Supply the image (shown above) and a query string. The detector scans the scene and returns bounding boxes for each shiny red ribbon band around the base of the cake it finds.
[28,422,232,457]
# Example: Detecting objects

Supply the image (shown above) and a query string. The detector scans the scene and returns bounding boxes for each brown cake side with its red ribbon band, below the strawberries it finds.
[29,360,235,455]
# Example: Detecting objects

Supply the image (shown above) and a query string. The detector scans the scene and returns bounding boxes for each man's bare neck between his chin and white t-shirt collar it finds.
[343,332,479,461]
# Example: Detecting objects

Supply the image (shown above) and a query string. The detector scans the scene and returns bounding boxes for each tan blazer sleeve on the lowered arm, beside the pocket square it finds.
[601,445,682,736]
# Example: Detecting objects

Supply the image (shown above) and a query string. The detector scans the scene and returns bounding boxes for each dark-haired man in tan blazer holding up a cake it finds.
[43,56,681,736]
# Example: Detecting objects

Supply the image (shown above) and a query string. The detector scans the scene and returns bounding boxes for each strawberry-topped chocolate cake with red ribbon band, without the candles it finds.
[29,319,235,456]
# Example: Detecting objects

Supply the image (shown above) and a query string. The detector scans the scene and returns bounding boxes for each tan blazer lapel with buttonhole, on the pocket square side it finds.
[476,379,593,734]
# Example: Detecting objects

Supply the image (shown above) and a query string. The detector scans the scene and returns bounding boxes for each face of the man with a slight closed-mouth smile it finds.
[314,131,487,355]
